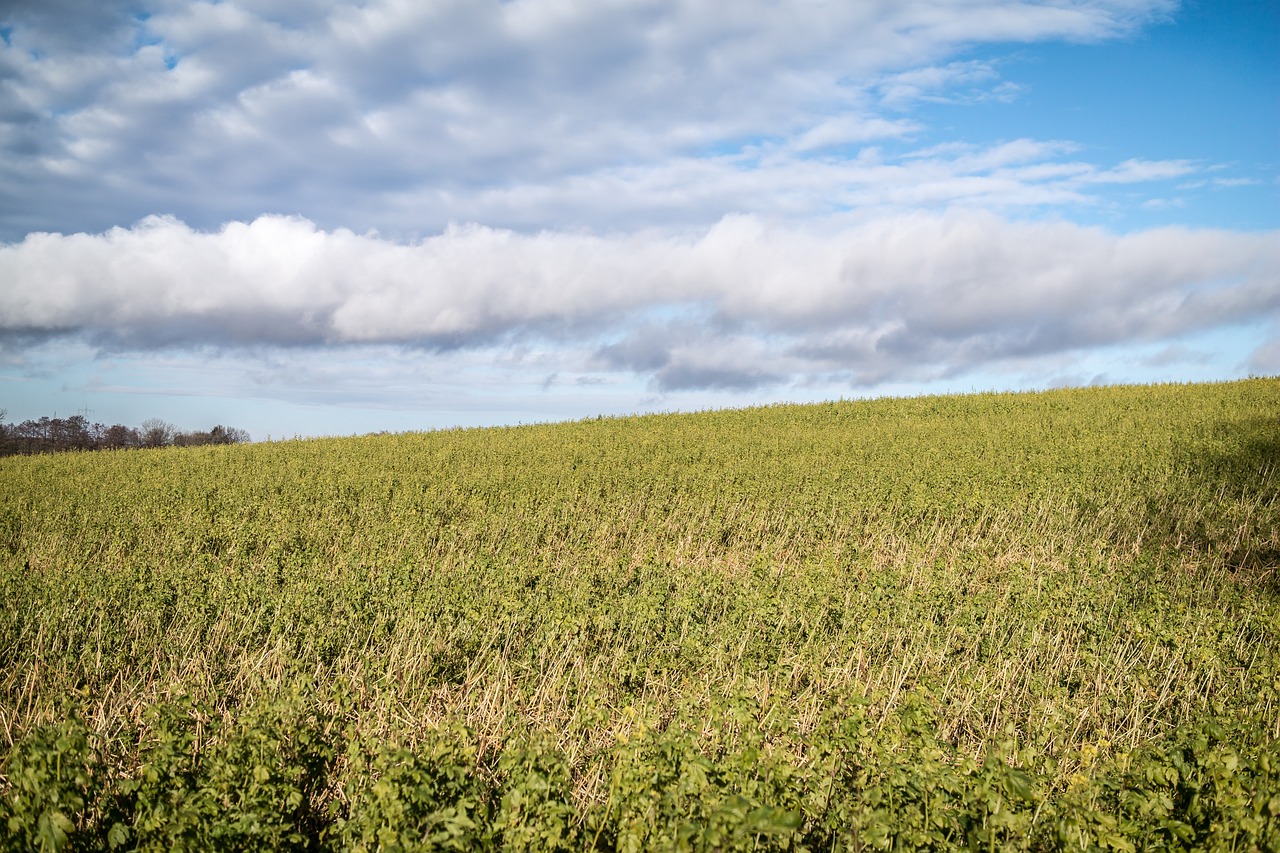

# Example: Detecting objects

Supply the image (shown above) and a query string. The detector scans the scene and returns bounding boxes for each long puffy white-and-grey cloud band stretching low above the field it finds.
[0,209,1280,391]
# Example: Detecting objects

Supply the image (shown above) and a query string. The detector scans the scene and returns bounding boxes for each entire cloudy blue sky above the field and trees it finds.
[0,0,1280,441]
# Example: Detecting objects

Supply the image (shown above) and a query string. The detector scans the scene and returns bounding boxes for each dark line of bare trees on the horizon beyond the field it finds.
[0,409,250,456]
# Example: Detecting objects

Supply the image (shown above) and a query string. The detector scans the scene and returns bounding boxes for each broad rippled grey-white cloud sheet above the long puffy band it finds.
[0,0,1174,240]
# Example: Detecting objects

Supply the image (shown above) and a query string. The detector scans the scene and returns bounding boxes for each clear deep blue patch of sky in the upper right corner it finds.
[913,0,1280,229]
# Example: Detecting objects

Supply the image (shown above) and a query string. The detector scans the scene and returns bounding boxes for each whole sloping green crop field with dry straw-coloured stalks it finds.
[0,378,1280,850]
